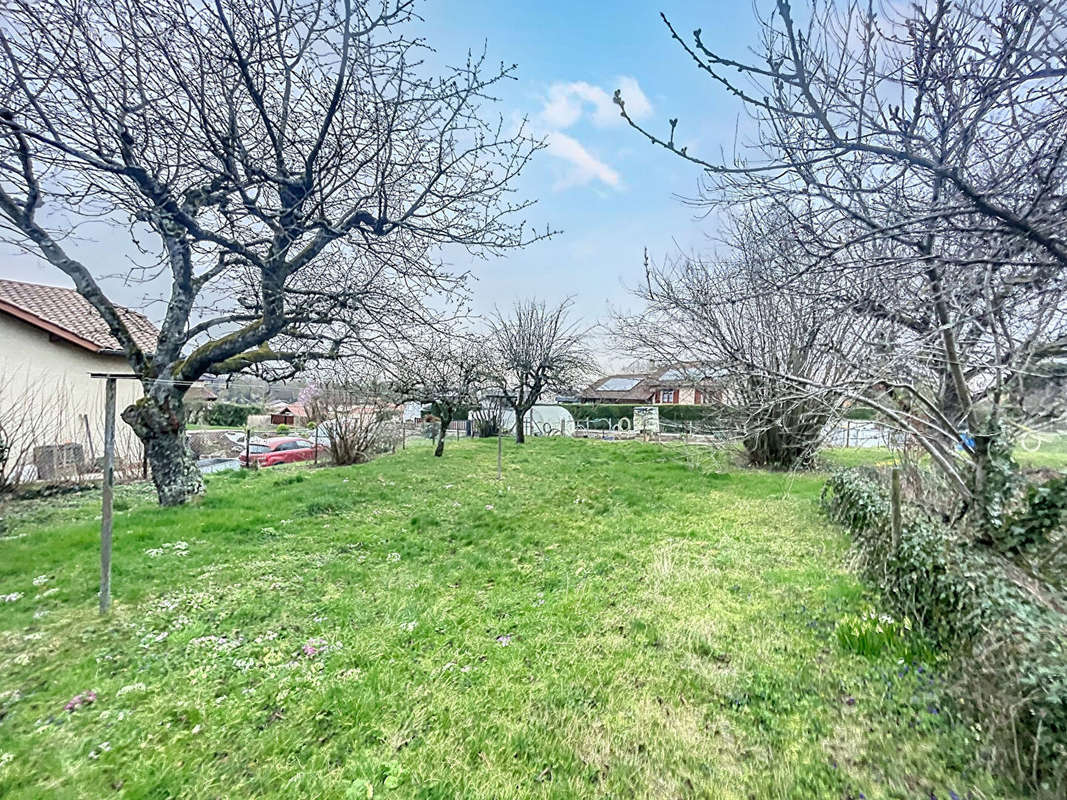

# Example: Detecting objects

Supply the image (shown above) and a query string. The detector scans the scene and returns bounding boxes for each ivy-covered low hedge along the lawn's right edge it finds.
[823,470,1067,797]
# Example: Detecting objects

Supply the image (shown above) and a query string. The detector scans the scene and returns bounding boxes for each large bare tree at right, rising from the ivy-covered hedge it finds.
[617,0,1067,529]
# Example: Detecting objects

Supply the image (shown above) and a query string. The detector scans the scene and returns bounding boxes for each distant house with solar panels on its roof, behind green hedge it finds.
[578,364,717,405]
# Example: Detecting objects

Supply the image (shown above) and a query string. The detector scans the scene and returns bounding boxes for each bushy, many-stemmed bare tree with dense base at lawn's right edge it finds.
[614,211,871,469]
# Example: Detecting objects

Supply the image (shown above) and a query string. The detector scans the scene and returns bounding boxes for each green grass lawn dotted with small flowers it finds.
[0,439,1013,800]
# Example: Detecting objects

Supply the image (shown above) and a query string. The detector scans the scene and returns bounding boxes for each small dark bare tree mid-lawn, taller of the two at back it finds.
[489,299,595,444]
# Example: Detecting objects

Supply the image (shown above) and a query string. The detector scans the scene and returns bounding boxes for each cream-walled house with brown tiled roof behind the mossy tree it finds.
[0,279,159,478]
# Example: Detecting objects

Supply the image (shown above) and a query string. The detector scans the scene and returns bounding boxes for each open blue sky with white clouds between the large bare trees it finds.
[0,0,757,354]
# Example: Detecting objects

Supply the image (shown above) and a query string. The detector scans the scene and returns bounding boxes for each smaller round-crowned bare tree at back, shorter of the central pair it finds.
[392,330,487,458]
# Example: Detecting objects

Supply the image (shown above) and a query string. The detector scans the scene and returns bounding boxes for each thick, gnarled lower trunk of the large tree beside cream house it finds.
[123,384,204,506]
